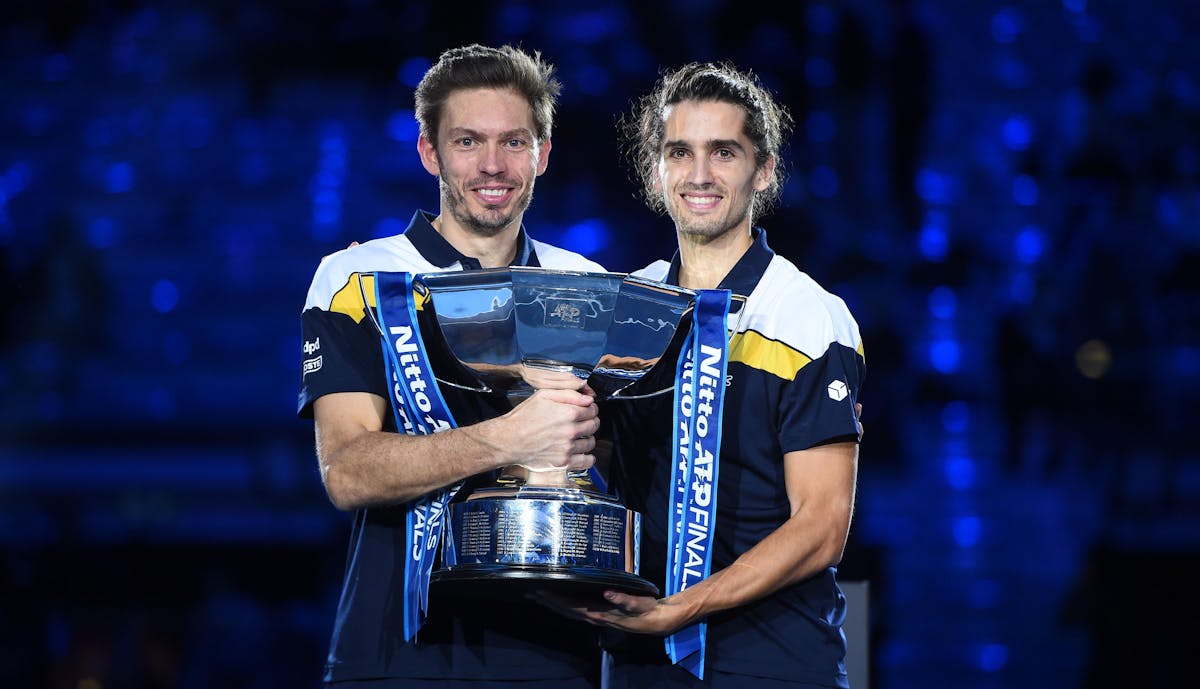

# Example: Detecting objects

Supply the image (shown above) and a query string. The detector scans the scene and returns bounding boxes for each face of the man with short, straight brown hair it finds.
[416,89,550,236]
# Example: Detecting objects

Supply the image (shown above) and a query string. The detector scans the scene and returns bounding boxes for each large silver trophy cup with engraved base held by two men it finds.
[405,268,695,595]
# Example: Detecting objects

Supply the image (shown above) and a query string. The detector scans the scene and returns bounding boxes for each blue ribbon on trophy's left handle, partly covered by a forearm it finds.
[374,272,462,642]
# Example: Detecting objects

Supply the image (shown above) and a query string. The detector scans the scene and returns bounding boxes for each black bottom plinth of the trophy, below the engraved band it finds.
[430,565,659,598]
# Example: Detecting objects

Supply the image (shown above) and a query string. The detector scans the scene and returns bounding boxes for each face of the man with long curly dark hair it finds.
[656,101,774,239]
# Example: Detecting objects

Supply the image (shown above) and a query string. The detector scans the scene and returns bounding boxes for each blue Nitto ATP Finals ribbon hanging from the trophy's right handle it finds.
[665,289,730,679]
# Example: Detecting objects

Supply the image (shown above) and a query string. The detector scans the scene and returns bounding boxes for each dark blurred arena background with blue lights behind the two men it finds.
[0,0,1200,689]
